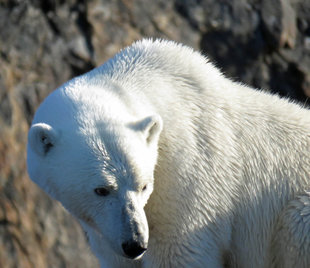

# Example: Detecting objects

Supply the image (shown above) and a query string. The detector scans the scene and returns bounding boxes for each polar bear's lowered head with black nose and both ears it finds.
[27,81,162,259]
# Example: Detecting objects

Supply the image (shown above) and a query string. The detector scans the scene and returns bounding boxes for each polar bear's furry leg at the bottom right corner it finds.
[271,192,310,268]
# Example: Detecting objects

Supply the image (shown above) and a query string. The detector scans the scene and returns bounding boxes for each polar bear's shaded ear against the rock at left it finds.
[28,123,58,156]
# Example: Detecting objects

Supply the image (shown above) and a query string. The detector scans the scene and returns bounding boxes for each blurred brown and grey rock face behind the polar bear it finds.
[0,0,310,268]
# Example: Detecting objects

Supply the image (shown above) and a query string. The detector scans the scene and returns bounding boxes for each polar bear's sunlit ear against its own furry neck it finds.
[132,115,163,144]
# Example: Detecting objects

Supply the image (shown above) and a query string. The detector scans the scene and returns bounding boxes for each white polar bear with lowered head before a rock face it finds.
[27,40,310,268]
